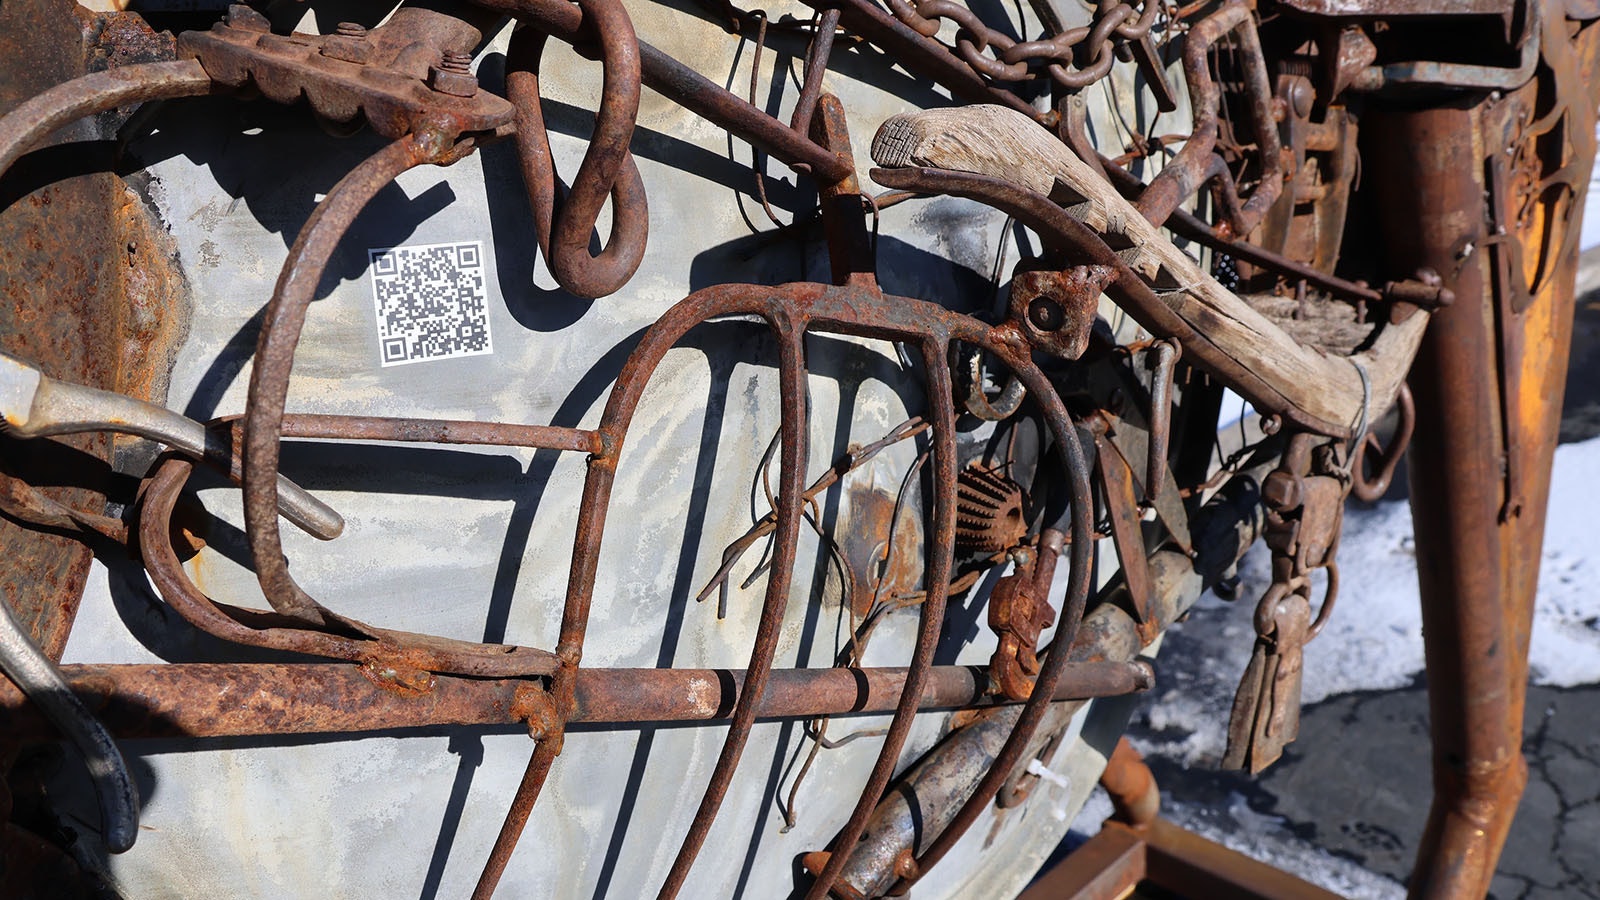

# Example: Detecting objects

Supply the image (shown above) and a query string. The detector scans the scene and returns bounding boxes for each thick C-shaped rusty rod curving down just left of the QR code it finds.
[242,136,429,625]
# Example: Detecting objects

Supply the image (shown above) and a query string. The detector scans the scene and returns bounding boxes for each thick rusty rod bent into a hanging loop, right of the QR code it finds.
[506,0,650,298]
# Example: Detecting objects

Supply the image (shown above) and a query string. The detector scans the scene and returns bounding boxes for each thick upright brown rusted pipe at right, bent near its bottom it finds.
[1363,106,1516,897]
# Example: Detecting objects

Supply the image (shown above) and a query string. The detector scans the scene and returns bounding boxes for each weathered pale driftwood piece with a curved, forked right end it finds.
[872,106,1429,428]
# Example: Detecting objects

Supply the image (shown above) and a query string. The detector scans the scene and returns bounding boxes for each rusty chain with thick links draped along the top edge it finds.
[885,0,1163,90]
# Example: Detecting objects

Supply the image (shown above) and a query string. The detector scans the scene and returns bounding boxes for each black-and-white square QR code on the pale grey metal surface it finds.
[366,240,494,367]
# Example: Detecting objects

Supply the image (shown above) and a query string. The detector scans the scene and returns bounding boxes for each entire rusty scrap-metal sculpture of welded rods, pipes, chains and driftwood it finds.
[0,0,1600,898]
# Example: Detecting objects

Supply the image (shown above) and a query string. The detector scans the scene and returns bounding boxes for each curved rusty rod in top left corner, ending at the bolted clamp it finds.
[0,59,213,175]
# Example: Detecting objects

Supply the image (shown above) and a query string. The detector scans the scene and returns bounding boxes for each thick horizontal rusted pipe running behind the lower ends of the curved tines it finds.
[0,661,1154,740]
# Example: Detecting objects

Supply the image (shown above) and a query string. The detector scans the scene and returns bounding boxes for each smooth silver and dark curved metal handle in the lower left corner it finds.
[0,599,139,854]
